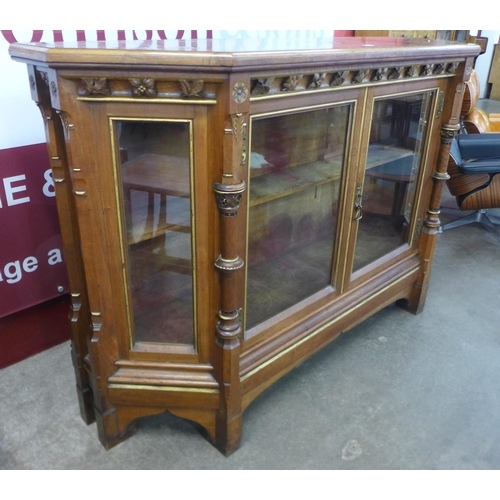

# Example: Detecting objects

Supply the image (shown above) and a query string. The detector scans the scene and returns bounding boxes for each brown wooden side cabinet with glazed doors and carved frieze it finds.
[10,38,479,454]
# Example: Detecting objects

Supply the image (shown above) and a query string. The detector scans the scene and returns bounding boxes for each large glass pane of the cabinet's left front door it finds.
[246,105,351,329]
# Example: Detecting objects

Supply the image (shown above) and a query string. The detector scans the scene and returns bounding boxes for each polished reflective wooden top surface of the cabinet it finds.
[9,37,480,68]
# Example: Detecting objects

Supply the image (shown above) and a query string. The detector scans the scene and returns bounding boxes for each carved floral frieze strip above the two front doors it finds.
[250,62,459,98]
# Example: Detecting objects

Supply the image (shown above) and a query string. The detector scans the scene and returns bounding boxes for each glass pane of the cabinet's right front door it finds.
[353,92,432,271]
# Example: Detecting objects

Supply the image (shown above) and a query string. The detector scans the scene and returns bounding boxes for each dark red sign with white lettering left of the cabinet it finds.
[0,144,68,317]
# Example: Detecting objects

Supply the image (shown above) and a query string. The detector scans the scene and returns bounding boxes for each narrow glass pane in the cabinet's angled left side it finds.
[116,120,194,344]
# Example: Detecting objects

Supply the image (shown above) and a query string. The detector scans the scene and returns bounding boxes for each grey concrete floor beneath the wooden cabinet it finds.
[0,102,500,470]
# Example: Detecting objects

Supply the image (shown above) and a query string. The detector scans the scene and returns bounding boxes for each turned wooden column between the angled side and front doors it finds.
[213,76,249,455]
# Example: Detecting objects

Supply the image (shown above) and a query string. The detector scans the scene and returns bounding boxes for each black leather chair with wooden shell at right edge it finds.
[439,133,500,238]
